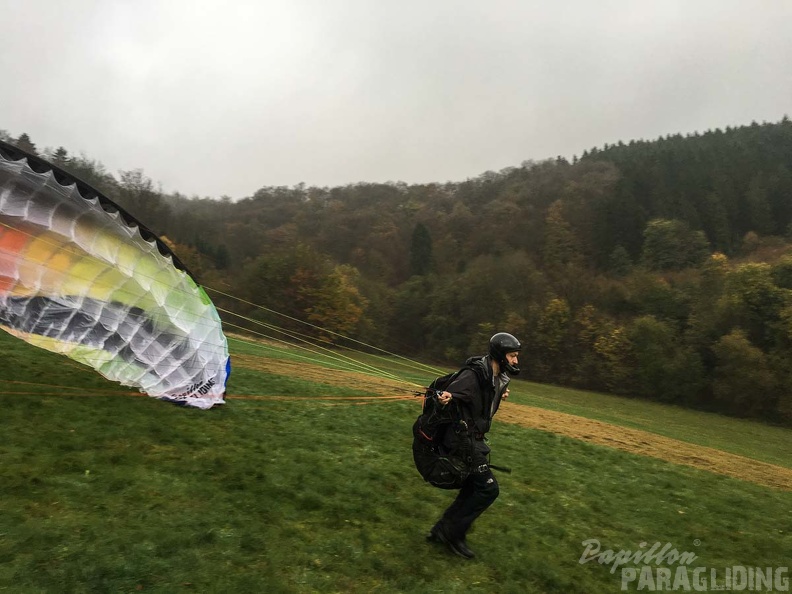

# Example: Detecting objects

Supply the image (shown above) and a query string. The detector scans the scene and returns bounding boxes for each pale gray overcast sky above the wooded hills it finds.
[0,0,792,198]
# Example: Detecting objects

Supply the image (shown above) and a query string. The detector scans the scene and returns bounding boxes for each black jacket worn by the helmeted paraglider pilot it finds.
[446,355,510,450]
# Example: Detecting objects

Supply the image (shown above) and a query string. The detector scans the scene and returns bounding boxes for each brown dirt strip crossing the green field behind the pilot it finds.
[229,355,792,491]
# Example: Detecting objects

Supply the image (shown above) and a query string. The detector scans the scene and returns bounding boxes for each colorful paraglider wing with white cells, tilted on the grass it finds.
[0,142,230,408]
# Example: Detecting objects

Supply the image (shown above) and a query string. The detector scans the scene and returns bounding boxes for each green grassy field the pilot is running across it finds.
[0,333,792,593]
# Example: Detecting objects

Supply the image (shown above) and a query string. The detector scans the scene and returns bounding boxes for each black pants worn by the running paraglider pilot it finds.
[440,456,500,539]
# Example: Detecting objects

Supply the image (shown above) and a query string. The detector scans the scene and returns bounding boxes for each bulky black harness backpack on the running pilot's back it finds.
[413,367,475,489]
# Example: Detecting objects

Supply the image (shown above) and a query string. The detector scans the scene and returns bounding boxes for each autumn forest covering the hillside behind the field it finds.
[0,116,792,425]
